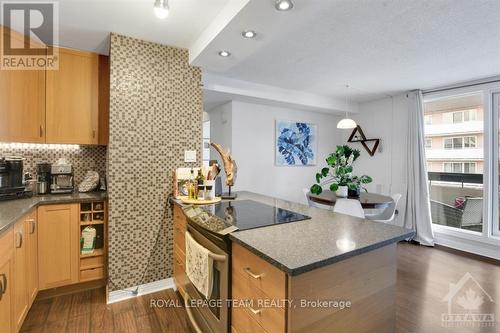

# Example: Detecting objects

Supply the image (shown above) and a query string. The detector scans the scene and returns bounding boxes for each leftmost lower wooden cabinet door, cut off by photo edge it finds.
[0,227,14,333]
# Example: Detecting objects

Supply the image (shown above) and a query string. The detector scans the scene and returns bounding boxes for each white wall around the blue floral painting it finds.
[209,101,342,202]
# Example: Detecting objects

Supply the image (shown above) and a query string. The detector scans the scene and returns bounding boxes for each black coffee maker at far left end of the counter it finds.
[0,156,27,200]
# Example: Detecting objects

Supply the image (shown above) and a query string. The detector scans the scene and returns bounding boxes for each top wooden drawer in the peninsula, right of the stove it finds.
[232,243,286,299]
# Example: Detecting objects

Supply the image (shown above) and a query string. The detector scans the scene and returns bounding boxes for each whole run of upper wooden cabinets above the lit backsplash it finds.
[0,26,109,145]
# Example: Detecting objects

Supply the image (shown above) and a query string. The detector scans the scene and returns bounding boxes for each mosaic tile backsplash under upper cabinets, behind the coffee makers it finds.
[0,143,106,186]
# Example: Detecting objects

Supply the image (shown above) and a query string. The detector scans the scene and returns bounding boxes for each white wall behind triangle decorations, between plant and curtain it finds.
[344,94,408,225]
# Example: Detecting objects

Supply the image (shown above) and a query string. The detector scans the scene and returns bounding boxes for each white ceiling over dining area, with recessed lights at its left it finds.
[193,0,500,102]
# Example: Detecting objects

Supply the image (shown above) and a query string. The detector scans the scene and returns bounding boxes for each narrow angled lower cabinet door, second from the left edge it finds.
[12,218,29,332]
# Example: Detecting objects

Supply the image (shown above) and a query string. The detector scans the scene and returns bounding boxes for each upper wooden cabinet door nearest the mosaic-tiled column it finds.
[46,48,99,144]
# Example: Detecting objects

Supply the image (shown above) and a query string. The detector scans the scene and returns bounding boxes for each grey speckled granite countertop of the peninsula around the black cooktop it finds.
[178,192,414,275]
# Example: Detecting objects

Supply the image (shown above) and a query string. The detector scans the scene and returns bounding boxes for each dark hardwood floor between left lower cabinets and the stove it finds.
[21,288,191,333]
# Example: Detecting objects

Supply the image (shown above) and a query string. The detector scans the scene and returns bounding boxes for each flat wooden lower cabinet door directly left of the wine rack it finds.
[38,204,79,290]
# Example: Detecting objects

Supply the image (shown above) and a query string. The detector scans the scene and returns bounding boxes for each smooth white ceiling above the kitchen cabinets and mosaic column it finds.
[28,0,229,54]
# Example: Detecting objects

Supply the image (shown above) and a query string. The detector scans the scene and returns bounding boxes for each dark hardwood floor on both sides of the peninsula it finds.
[22,243,500,333]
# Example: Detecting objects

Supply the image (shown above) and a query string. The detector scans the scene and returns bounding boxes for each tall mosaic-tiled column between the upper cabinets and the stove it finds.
[108,34,203,291]
